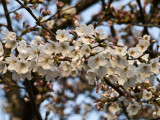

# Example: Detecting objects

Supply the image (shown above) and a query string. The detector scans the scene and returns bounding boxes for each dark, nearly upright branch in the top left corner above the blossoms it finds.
[1,0,13,31]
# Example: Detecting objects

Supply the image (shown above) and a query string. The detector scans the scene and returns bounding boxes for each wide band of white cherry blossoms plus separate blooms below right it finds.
[0,24,160,115]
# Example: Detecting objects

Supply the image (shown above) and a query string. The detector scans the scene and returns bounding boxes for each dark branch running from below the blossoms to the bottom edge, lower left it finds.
[26,80,42,120]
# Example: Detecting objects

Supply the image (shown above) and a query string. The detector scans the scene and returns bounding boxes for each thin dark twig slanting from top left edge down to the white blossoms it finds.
[16,0,55,36]
